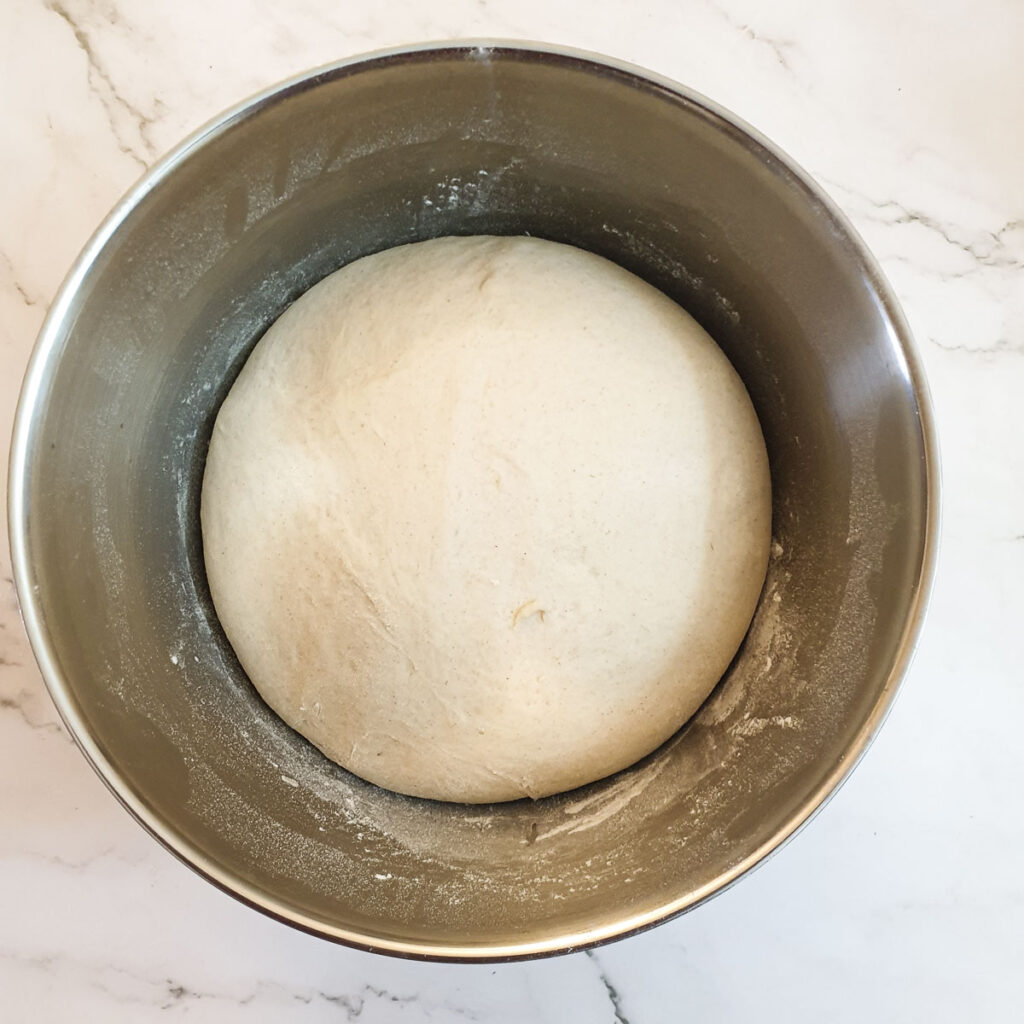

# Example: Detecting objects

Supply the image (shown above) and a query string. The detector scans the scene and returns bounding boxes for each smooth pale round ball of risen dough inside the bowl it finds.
[202,237,771,803]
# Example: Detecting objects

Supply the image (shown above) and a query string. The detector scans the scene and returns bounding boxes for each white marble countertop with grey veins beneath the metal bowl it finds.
[0,0,1024,1024]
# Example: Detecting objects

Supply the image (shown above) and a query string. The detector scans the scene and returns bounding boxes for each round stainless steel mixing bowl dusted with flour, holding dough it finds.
[9,44,937,959]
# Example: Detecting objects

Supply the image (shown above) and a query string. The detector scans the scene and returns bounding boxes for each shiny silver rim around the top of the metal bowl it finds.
[7,38,940,963]
